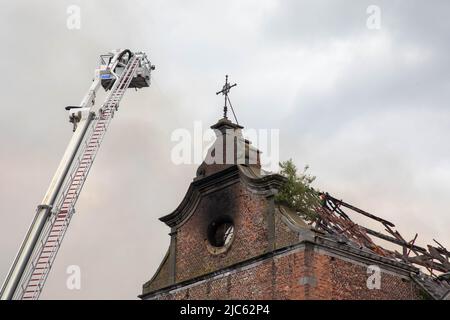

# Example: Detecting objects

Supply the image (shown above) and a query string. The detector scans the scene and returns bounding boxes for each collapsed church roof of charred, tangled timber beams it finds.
[309,193,450,299]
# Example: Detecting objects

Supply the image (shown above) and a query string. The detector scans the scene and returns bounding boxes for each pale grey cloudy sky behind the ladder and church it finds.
[0,0,450,299]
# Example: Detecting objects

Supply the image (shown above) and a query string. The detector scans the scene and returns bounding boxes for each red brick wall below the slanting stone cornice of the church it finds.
[149,248,421,300]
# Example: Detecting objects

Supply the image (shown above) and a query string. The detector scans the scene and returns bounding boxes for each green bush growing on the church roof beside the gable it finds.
[275,159,320,221]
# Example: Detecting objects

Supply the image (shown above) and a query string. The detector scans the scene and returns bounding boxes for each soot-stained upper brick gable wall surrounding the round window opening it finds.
[175,183,268,282]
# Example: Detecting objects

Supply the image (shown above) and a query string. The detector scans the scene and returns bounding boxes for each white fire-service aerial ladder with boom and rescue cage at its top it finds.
[1,49,155,300]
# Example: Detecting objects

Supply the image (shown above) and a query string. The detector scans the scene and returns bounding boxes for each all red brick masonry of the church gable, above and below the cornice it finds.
[141,162,424,300]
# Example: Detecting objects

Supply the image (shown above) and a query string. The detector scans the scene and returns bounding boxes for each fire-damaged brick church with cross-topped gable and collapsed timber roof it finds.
[140,79,450,300]
